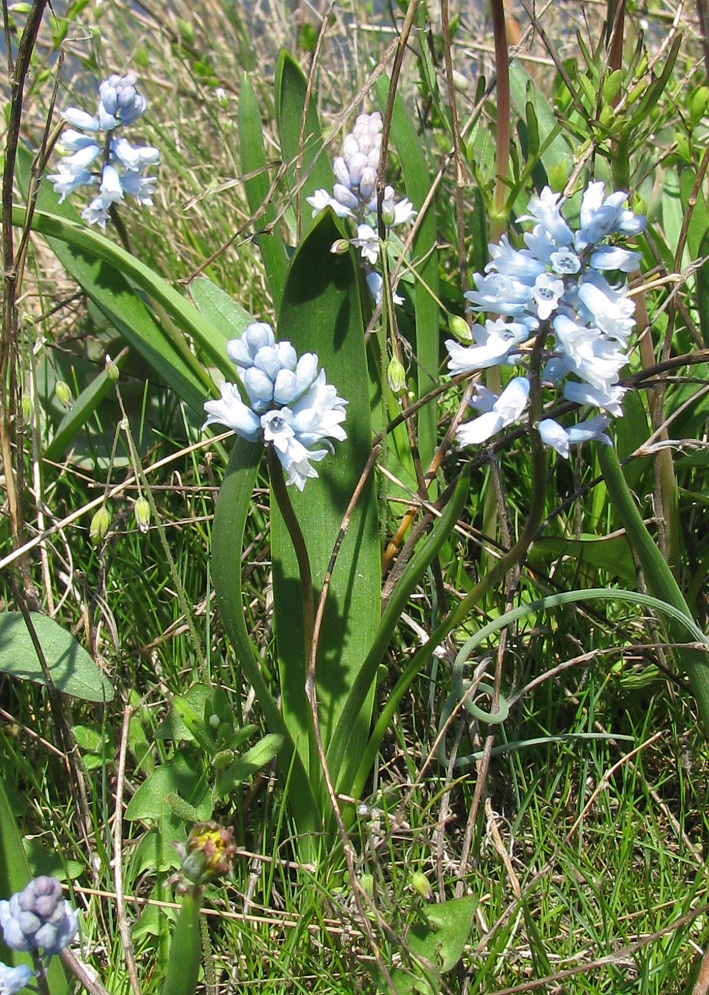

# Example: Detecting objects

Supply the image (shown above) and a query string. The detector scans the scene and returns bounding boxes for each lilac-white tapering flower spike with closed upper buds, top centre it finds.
[307,111,416,303]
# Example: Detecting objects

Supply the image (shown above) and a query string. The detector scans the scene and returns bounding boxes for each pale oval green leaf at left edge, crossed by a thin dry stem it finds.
[0,612,113,702]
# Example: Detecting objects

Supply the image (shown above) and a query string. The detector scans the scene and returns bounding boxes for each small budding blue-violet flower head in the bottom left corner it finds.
[0,875,79,961]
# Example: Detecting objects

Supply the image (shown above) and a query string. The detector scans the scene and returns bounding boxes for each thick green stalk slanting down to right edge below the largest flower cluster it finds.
[598,446,709,735]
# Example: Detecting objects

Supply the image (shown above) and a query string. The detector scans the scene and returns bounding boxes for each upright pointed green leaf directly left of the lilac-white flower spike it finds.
[276,51,335,235]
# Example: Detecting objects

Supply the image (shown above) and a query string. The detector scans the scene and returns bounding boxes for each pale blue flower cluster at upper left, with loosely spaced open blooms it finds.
[47,73,160,228]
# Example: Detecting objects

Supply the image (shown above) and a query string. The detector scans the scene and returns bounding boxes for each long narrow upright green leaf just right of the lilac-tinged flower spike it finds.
[376,76,440,471]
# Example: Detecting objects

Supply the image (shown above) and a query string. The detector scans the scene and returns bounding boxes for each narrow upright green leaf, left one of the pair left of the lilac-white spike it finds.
[238,75,288,311]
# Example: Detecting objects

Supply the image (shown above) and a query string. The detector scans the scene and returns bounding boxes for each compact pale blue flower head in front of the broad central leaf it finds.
[204,322,347,491]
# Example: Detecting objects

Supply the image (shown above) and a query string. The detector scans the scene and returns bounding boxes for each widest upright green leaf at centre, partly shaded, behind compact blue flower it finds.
[271,212,381,791]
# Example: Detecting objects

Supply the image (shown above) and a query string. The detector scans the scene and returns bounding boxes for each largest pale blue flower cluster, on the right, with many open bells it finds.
[446,182,646,459]
